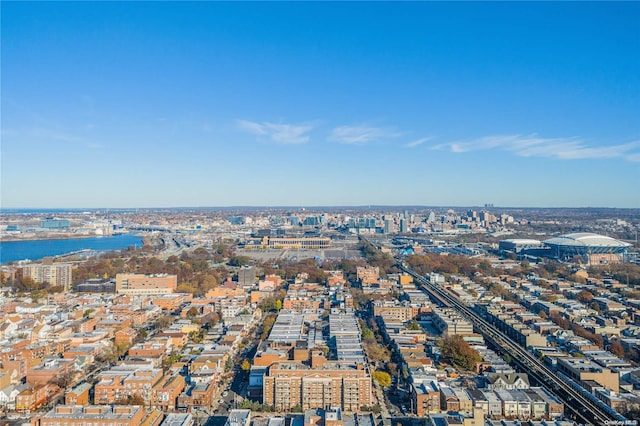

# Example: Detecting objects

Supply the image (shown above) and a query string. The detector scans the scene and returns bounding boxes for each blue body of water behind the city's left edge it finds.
[0,234,142,264]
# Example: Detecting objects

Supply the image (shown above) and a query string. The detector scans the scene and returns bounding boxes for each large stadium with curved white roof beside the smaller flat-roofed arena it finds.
[543,232,631,265]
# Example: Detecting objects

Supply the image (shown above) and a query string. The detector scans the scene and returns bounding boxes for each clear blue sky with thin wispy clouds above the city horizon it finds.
[1,2,640,208]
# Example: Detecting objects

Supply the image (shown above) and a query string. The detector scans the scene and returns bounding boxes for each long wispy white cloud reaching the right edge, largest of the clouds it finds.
[431,135,640,161]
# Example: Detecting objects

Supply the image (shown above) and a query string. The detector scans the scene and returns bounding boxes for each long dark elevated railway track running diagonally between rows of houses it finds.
[398,262,625,425]
